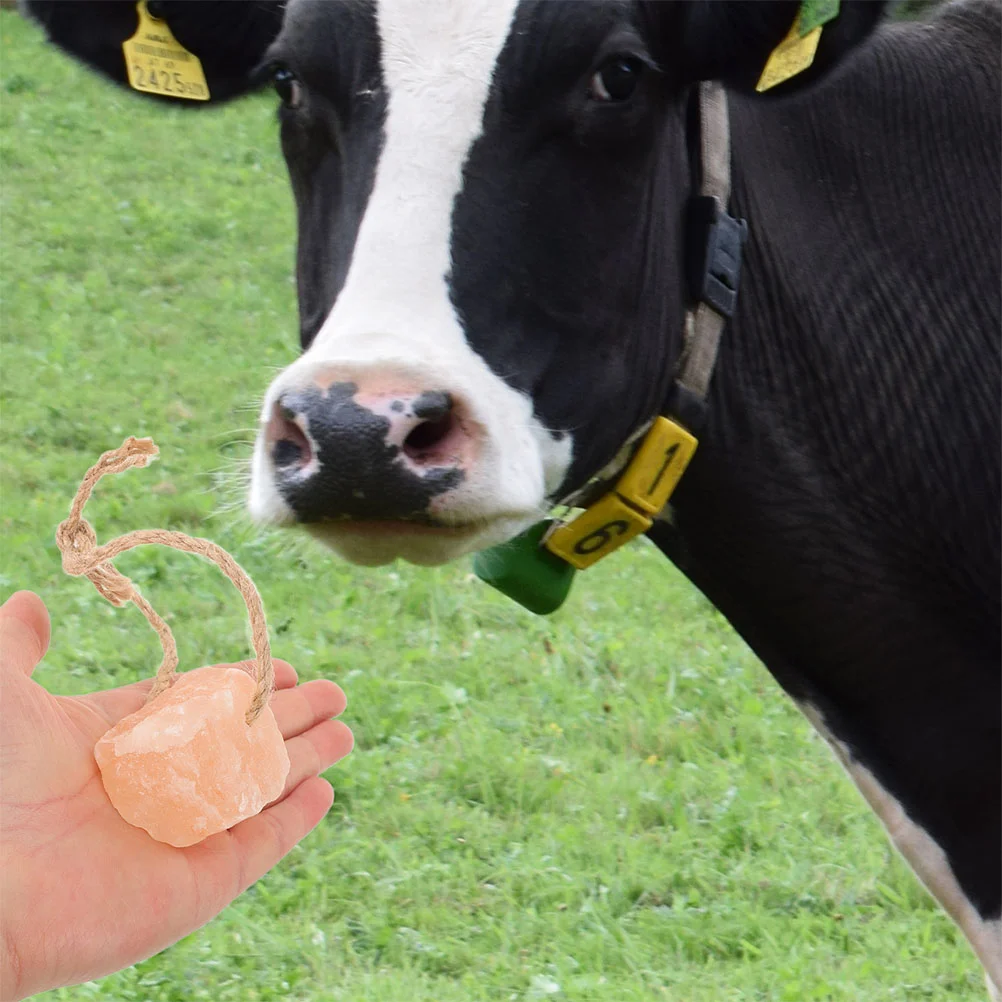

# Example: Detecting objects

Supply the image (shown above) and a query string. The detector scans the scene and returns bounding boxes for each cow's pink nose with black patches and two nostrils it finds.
[267,383,472,522]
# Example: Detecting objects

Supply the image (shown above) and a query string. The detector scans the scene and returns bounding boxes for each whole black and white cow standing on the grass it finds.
[27,0,1002,989]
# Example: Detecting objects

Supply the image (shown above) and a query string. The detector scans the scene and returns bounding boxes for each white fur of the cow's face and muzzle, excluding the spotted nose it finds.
[249,0,572,564]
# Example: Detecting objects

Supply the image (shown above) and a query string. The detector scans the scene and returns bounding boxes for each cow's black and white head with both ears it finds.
[30,0,881,563]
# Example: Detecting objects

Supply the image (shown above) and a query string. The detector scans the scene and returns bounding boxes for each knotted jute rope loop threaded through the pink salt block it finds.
[56,436,275,723]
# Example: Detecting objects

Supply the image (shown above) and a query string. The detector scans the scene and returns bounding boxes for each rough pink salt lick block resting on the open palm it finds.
[94,665,289,847]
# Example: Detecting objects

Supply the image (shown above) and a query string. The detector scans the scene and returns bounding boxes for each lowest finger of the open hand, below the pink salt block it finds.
[229,776,334,894]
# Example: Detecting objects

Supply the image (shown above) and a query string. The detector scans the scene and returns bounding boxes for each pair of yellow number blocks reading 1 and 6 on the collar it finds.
[543,417,697,570]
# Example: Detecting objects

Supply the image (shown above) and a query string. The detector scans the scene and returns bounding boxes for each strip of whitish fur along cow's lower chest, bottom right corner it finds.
[800,702,1002,998]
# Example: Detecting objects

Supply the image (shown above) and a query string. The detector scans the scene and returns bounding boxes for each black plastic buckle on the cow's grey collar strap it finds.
[685,195,748,319]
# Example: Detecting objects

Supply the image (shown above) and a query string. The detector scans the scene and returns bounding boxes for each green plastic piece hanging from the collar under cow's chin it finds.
[473,520,574,616]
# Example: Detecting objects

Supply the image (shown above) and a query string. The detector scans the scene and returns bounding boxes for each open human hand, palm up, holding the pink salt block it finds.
[0,591,353,1002]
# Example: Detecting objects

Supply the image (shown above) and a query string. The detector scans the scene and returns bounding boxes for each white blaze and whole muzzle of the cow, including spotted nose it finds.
[249,0,571,563]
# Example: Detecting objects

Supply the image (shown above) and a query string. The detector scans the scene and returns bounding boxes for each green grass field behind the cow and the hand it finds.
[0,12,984,1002]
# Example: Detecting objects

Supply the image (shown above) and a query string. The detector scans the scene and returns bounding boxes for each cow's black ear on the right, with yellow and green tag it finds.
[670,0,886,95]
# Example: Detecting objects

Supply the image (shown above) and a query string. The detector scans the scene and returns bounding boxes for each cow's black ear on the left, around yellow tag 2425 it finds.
[21,0,286,106]
